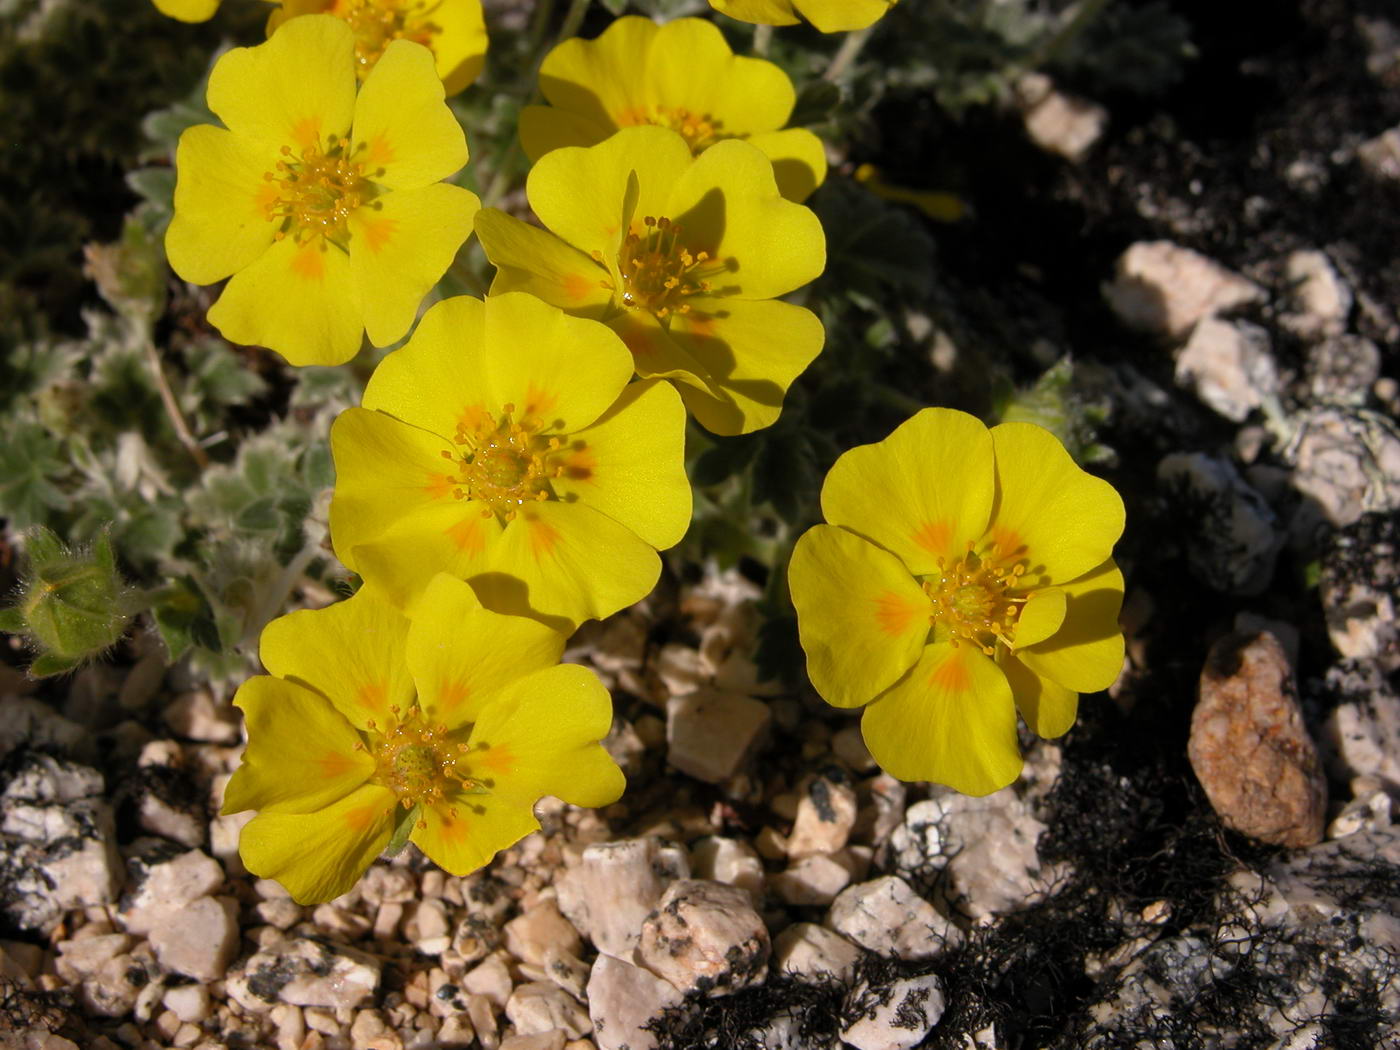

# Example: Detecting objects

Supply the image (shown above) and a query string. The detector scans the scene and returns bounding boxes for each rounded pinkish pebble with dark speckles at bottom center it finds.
[637,879,771,997]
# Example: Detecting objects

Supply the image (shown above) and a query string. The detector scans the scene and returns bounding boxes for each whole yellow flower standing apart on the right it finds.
[788,409,1123,795]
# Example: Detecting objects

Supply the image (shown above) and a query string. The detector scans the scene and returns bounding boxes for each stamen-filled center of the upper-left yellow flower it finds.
[263,137,374,241]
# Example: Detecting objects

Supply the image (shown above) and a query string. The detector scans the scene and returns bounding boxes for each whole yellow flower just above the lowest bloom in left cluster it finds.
[330,294,690,630]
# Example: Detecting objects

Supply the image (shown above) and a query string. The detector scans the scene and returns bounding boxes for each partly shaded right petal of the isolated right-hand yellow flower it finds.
[1016,559,1123,693]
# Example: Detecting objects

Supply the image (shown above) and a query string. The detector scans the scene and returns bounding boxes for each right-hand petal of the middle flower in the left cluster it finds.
[554,381,690,550]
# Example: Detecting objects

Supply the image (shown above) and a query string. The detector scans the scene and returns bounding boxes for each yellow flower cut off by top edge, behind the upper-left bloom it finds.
[267,0,487,95]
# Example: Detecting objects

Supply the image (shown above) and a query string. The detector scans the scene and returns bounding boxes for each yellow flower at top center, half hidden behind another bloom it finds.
[519,15,826,203]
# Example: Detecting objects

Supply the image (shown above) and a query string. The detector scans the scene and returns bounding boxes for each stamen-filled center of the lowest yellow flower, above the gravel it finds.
[368,704,491,809]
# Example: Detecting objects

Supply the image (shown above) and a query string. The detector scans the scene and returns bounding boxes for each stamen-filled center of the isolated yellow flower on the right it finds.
[924,545,1029,657]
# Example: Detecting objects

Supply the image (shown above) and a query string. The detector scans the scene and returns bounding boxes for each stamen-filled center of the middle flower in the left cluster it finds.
[442,405,571,521]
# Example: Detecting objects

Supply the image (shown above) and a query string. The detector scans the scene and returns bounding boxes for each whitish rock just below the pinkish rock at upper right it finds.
[1176,318,1278,423]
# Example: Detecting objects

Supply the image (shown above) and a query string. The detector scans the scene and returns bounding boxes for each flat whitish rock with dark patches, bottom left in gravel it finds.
[225,934,381,1014]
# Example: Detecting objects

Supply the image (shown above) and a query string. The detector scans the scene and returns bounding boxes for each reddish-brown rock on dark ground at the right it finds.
[1187,631,1327,848]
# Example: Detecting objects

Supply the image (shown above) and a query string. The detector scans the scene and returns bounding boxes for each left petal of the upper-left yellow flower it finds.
[165,125,276,284]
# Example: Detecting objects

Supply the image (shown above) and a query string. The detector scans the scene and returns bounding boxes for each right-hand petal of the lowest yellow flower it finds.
[466,664,623,806]
